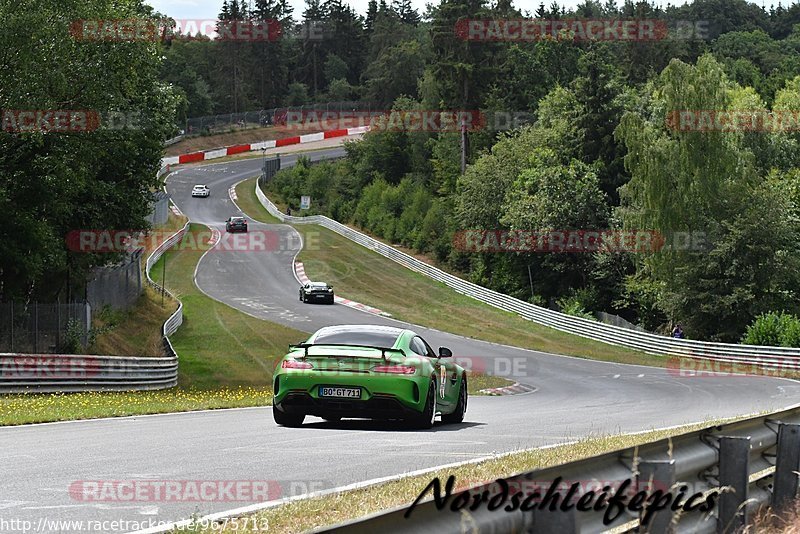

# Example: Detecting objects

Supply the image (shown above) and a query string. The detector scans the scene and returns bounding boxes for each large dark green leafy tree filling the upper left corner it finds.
[0,0,179,302]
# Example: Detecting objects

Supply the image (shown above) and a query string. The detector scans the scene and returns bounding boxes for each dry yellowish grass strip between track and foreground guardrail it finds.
[200,420,730,534]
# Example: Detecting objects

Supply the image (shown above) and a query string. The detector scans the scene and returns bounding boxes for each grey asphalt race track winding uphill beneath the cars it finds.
[0,144,800,532]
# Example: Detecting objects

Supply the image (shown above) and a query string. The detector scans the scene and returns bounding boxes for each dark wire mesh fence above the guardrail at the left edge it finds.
[0,302,91,354]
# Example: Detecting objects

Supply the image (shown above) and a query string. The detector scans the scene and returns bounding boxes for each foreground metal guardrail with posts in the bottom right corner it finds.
[317,407,800,534]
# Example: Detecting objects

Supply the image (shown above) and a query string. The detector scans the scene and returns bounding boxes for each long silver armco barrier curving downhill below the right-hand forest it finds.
[256,184,800,371]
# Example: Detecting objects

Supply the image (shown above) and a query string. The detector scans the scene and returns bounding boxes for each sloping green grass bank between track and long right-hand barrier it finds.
[242,182,670,367]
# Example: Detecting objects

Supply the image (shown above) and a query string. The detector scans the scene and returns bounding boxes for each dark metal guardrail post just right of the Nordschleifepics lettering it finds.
[717,436,750,533]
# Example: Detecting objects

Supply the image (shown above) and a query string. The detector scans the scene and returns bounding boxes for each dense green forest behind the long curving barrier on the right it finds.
[252,0,800,342]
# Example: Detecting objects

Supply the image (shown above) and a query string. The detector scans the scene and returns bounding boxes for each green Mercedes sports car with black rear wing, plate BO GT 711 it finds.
[272,325,467,428]
